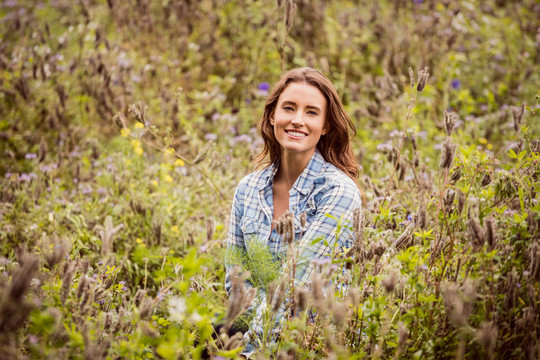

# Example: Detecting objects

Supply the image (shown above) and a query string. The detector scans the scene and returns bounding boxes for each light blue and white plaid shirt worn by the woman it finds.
[225,151,361,355]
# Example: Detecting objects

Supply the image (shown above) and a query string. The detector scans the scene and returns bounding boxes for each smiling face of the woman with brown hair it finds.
[270,82,328,158]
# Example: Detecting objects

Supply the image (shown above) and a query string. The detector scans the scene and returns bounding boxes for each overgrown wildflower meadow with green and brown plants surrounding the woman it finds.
[0,0,540,359]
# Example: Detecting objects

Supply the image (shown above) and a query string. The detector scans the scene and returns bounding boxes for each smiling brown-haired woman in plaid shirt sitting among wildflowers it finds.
[226,68,361,355]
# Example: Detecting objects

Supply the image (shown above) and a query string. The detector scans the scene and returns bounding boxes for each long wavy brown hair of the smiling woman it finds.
[255,67,358,186]
